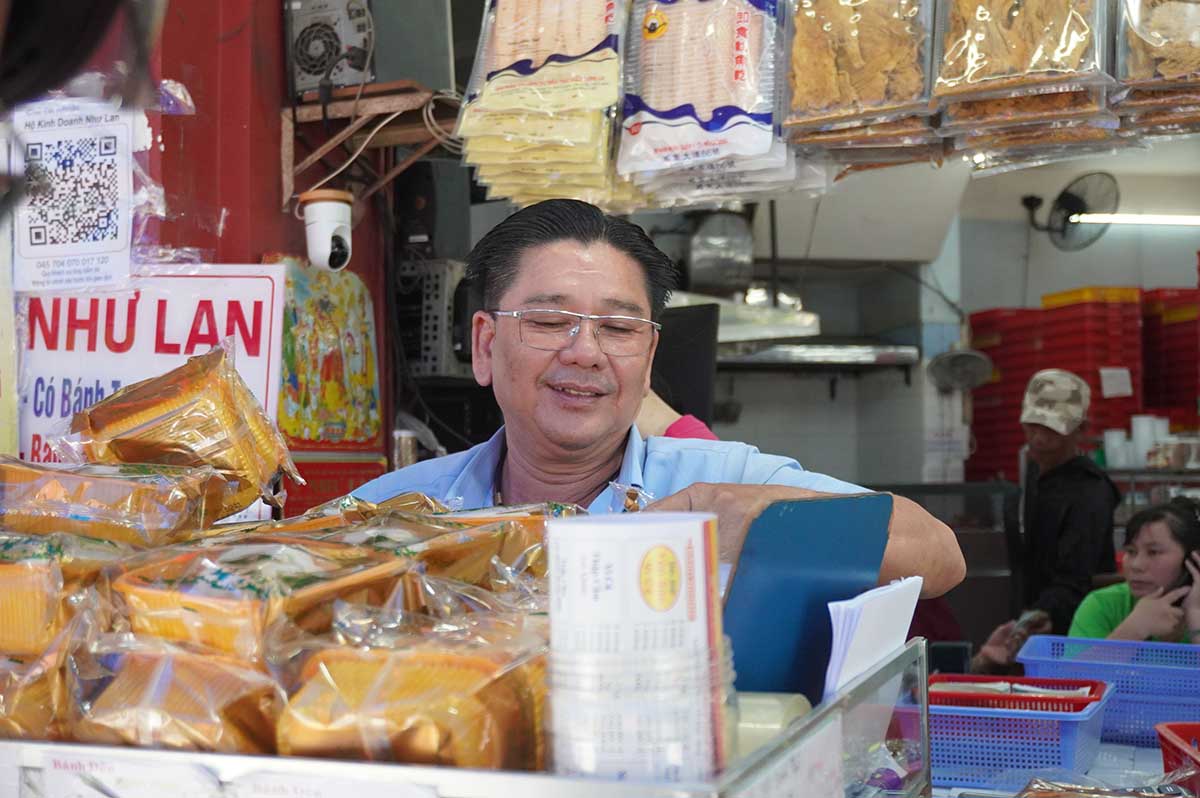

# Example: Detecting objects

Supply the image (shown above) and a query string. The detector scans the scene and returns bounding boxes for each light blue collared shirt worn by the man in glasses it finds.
[354,426,866,512]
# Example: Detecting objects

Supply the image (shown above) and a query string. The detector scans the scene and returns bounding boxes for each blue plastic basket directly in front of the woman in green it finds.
[1016,636,1200,748]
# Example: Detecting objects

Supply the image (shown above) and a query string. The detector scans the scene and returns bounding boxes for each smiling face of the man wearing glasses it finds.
[472,240,658,454]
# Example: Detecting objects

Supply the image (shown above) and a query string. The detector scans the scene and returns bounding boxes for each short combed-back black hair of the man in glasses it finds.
[467,199,678,318]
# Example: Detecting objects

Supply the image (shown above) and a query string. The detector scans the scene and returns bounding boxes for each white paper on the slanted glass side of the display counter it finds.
[743,713,845,798]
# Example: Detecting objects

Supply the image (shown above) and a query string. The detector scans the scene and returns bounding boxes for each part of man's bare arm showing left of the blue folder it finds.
[646,482,829,569]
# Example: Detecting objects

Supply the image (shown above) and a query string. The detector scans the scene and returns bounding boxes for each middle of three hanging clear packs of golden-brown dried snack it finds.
[934,0,1112,101]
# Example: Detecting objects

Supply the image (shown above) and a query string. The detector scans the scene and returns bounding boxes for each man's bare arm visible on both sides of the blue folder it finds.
[647,482,966,599]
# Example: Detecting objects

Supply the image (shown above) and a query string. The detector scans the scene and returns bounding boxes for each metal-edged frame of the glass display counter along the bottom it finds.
[0,638,932,798]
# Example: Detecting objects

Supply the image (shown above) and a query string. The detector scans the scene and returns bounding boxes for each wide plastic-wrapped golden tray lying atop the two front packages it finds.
[113,538,409,662]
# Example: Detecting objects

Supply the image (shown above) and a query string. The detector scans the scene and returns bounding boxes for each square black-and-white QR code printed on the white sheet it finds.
[25,136,121,246]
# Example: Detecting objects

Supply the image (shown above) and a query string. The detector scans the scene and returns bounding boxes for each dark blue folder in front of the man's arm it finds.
[724,493,892,706]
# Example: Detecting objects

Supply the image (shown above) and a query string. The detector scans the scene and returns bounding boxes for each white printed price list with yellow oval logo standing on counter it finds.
[547,512,733,782]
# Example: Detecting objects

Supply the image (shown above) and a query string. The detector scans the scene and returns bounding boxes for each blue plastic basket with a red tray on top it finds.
[929,688,1112,791]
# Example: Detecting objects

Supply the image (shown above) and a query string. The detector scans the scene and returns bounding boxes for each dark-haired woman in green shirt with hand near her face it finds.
[1069,498,1200,644]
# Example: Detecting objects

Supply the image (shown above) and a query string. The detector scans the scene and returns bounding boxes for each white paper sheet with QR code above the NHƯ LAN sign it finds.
[13,100,133,292]
